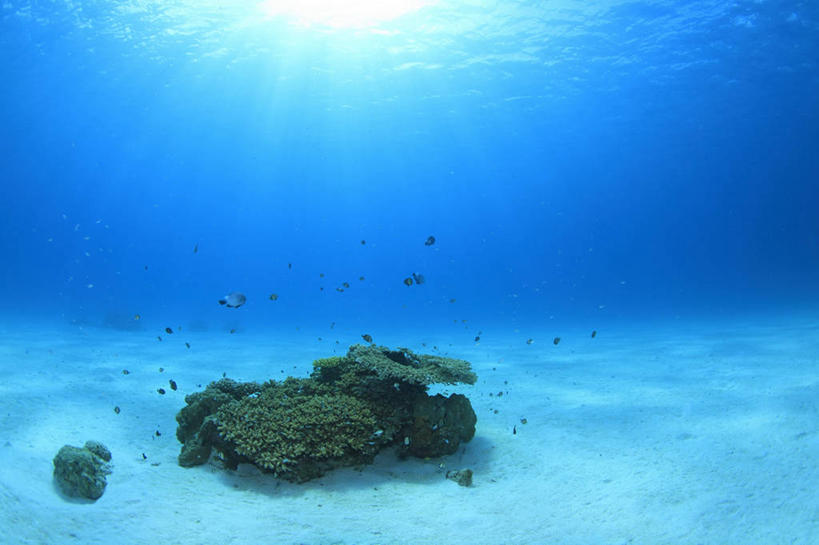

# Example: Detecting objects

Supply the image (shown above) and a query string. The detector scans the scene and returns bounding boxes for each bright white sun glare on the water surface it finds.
[260,0,434,28]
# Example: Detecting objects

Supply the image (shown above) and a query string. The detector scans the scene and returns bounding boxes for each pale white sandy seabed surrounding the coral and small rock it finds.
[0,321,819,545]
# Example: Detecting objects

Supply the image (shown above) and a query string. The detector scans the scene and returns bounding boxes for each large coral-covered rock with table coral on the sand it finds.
[176,344,477,482]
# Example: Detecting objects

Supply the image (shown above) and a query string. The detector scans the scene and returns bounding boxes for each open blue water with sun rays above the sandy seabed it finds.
[0,0,819,344]
